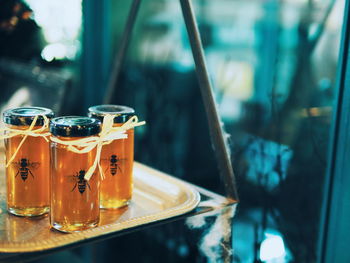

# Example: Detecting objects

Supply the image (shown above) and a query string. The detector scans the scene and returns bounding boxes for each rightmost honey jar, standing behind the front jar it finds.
[89,105,135,208]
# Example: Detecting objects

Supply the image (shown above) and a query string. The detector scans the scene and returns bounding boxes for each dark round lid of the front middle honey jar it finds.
[50,116,101,137]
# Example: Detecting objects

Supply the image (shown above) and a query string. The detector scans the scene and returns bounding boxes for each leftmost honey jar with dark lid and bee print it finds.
[3,107,54,216]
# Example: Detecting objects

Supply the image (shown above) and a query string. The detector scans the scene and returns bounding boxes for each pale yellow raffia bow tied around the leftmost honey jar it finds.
[0,115,51,167]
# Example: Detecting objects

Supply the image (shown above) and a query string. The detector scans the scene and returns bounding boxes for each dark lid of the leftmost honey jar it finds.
[3,107,54,126]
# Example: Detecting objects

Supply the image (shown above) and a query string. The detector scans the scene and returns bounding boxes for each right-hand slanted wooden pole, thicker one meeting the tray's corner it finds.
[180,0,238,200]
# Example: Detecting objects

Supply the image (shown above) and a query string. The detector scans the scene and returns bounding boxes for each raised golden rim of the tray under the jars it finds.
[0,162,200,253]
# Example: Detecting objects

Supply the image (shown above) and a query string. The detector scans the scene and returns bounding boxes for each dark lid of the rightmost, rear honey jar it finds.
[89,104,135,123]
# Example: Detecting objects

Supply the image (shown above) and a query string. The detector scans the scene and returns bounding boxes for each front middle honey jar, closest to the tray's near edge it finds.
[50,116,101,232]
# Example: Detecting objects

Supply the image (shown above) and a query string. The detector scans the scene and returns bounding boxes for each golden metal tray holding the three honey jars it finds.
[0,163,200,253]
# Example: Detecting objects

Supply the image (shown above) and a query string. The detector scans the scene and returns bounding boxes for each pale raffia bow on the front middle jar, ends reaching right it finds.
[51,114,146,181]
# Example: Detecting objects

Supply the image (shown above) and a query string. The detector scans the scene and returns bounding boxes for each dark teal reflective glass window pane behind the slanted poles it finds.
[108,0,344,262]
